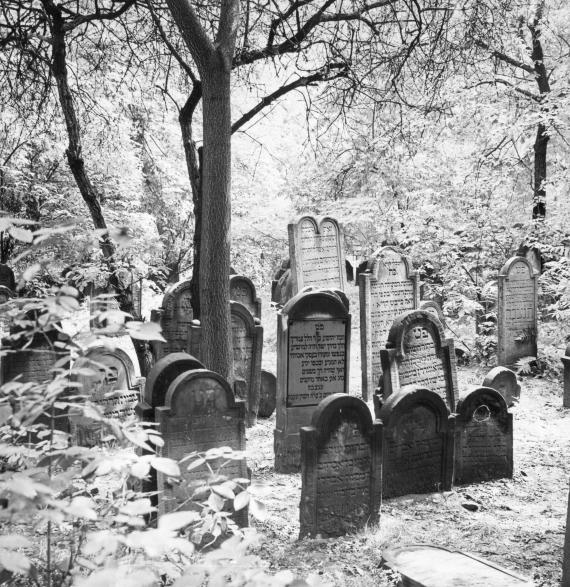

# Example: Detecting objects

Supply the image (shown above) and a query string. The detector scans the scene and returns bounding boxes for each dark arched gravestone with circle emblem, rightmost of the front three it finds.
[455,387,513,484]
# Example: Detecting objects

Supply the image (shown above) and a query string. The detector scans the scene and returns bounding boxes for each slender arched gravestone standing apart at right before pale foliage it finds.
[497,257,537,367]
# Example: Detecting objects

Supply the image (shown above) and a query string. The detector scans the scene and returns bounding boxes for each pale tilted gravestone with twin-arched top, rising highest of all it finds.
[288,216,346,295]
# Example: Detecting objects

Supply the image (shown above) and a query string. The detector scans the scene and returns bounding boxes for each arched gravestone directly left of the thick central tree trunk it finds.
[151,279,194,360]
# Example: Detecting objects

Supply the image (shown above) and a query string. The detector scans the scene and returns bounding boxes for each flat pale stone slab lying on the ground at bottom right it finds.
[382,544,534,587]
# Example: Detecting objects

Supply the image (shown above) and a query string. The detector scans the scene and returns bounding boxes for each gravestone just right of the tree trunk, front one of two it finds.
[230,302,263,426]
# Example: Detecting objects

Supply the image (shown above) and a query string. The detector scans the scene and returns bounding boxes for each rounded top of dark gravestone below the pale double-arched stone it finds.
[281,287,349,320]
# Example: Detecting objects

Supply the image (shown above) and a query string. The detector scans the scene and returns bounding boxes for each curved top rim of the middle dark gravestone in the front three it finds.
[378,385,449,433]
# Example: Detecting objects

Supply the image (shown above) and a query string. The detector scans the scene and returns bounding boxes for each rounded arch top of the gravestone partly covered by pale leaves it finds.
[164,369,245,418]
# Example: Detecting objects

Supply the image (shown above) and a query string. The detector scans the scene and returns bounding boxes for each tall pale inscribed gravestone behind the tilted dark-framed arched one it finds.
[359,247,419,401]
